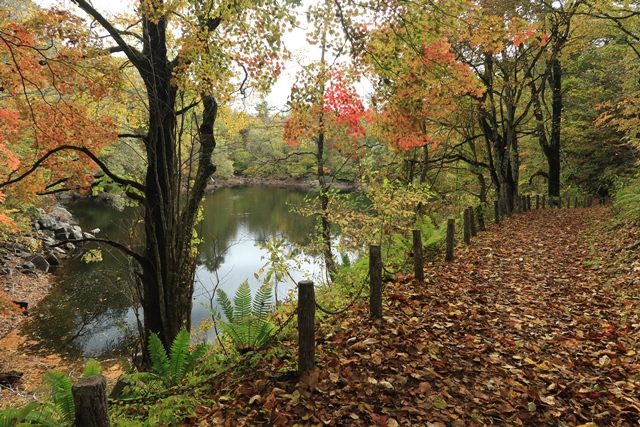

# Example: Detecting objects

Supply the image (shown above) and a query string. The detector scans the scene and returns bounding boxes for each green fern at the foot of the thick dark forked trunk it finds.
[149,329,206,386]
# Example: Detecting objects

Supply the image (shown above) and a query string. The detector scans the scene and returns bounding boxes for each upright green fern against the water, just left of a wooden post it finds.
[217,280,275,353]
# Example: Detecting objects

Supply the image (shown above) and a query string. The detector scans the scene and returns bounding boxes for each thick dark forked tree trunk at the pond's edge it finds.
[136,19,217,363]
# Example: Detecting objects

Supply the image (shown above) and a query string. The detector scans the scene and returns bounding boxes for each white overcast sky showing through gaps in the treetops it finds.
[35,0,371,111]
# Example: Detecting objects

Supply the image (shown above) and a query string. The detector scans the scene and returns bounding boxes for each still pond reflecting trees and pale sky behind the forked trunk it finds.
[28,186,322,357]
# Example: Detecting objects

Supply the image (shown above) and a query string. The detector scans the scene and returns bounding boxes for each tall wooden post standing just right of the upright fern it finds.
[298,280,316,378]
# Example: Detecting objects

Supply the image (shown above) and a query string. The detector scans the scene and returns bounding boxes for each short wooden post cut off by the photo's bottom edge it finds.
[71,375,109,427]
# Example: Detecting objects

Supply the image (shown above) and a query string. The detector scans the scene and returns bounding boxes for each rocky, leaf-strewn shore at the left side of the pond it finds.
[0,205,111,408]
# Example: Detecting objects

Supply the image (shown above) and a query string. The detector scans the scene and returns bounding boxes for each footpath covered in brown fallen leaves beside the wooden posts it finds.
[207,209,640,426]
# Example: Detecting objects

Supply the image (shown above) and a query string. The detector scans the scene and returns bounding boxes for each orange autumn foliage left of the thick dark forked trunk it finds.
[0,7,119,225]
